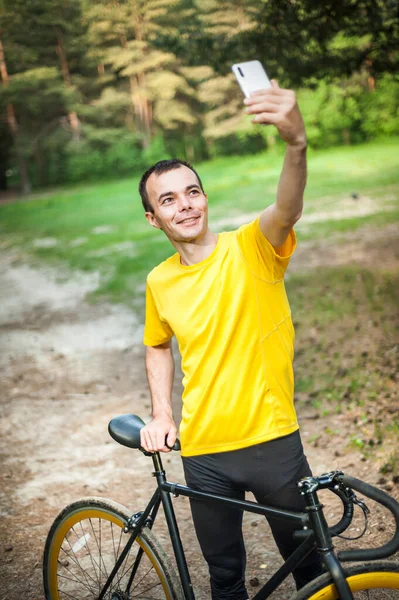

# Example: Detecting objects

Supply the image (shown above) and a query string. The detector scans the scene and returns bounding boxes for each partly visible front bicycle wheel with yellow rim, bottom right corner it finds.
[292,561,399,600]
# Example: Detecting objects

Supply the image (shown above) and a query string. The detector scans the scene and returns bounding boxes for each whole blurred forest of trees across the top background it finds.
[0,0,399,193]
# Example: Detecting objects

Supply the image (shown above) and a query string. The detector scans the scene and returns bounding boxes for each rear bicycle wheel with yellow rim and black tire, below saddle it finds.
[43,498,183,600]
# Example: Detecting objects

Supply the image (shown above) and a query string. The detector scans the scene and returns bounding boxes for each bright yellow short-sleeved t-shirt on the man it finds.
[144,218,298,456]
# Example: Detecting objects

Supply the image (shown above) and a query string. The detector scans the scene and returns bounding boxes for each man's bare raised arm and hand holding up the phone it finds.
[244,81,306,247]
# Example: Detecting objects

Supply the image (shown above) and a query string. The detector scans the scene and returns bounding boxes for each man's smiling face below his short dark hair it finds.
[145,165,208,242]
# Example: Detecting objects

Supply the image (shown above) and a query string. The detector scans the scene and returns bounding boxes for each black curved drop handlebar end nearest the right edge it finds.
[337,475,399,561]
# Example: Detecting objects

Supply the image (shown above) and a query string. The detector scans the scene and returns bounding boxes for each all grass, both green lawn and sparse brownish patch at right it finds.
[0,138,399,462]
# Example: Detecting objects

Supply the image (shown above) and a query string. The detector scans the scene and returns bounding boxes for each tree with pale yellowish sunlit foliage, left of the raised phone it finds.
[87,0,205,148]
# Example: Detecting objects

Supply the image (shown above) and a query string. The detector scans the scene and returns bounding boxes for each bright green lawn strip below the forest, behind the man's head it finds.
[0,138,399,309]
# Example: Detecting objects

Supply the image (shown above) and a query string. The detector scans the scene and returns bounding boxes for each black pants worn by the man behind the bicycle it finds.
[183,431,323,600]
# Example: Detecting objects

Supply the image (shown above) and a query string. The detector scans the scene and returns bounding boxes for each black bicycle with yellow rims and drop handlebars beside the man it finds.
[43,415,399,600]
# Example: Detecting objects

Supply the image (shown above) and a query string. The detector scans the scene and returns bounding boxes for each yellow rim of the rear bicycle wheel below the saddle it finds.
[49,508,173,600]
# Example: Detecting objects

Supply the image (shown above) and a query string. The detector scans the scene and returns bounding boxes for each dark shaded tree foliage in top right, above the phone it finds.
[172,0,399,87]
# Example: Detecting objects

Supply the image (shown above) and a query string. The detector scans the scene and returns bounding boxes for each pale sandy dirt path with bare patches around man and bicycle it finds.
[0,229,395,600]
